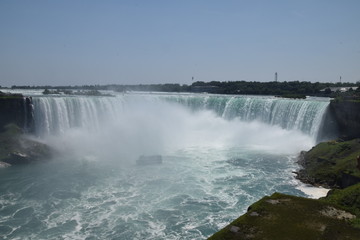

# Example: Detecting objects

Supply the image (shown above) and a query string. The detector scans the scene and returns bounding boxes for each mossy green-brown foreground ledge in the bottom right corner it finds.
[209,193,360,240]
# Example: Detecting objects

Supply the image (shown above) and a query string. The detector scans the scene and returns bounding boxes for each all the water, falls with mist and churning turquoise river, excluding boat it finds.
[0,93,329,239]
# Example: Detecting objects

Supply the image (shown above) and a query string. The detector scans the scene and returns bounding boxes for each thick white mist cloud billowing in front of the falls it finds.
[41,97,314,162]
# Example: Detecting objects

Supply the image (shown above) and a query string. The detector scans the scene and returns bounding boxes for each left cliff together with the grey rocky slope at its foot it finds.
[0,92,53,168]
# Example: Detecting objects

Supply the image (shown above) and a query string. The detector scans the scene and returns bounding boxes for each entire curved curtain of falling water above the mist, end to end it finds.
[33,94,329,139]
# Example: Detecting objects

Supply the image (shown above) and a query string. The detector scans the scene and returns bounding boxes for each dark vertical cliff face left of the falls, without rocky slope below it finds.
[0,92,34,132]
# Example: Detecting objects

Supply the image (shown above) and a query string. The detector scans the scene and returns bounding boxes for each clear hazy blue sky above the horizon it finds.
[0,0,360,86]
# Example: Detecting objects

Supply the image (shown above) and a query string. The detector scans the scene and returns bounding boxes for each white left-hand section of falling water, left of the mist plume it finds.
[33,96,122,135]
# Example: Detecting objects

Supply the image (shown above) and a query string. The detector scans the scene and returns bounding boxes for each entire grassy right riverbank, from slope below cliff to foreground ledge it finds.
[209,139,360,240]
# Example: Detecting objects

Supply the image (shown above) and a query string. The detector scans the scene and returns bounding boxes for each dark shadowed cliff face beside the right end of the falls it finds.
[330,101,360,140]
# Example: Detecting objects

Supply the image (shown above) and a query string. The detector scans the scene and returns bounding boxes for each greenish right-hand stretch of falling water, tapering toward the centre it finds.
[162,95,329,138]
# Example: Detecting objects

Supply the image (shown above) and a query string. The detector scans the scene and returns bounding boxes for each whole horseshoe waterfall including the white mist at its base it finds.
[29,93,329,159]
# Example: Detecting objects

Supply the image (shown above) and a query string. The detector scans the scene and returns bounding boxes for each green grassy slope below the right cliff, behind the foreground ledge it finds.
[298,139,360,187]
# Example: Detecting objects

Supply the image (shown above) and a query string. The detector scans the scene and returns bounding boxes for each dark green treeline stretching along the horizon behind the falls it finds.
[5,81,360,96]
